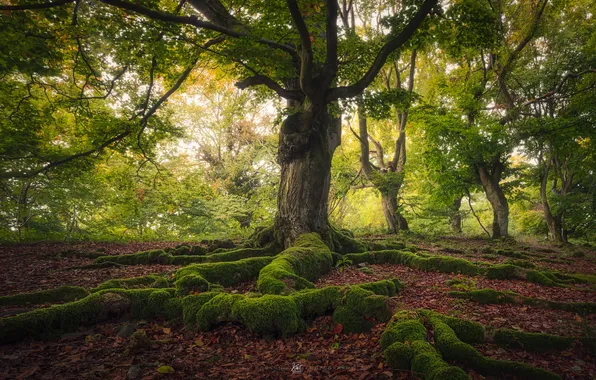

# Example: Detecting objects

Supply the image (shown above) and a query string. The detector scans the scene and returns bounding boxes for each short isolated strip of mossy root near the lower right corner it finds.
[493,329,575,352]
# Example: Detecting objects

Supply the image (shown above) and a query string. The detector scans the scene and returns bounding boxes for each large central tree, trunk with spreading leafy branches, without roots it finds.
[0,0,437,246]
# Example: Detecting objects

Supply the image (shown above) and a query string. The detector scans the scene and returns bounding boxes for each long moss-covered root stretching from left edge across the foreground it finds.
[0,280,401,343]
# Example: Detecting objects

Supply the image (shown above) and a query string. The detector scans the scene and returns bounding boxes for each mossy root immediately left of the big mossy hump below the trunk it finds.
[176,257,273,286]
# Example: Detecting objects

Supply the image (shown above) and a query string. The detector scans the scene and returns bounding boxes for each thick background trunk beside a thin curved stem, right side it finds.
[478,163,509,238]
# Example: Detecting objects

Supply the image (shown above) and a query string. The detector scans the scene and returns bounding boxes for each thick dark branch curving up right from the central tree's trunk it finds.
[327,0,438,102]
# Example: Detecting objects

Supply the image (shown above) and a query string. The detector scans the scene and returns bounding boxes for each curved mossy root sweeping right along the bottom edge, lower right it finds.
[431,318,560,380]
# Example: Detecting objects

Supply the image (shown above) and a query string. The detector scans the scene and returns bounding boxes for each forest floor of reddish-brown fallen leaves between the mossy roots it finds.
[0,237,596,379]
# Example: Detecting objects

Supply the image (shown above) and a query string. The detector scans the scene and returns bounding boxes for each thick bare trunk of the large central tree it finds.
[275,107,341,248]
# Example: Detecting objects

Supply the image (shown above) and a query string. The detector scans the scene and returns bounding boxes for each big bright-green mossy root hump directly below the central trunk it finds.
[257,233,333,294]
